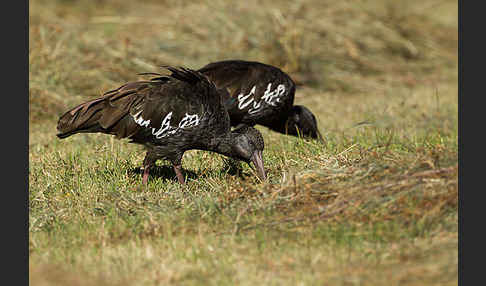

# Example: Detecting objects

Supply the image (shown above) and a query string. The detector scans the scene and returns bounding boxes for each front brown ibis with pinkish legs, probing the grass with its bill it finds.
[57,67,266,184]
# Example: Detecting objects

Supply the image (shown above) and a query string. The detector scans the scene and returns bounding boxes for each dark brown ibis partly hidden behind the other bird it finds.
[198,60,322,141]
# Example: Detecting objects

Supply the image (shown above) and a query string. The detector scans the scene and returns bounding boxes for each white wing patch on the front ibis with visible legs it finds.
[132,111,200,139]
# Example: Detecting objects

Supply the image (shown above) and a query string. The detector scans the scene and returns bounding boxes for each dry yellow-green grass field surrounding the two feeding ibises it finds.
[29,0,458,285]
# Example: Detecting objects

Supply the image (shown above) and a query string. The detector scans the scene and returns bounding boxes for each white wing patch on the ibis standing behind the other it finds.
[238,83,285,114]
